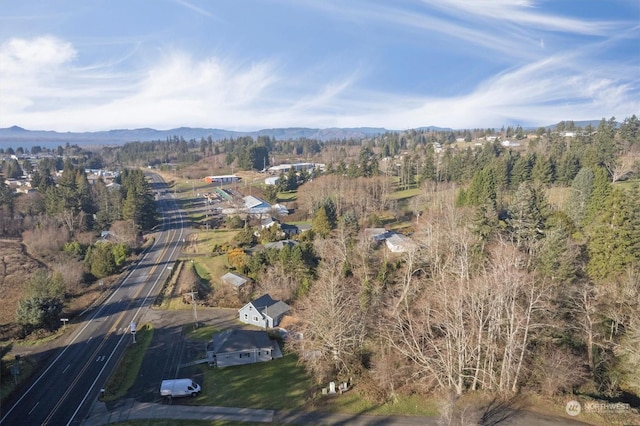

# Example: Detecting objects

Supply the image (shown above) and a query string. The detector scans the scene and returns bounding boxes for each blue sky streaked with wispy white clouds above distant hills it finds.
[0,0,640,131]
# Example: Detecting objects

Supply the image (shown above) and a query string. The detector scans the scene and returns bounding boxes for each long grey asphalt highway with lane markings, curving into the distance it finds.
[0,174,184,425]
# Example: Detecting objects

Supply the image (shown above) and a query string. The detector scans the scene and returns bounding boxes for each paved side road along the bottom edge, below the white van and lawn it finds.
[83,398,588,426]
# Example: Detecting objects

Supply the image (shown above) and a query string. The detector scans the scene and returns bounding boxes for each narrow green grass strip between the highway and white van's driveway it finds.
[102,324,153,401]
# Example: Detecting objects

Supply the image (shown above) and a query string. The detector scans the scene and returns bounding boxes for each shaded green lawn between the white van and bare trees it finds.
[196,354,311,410]
